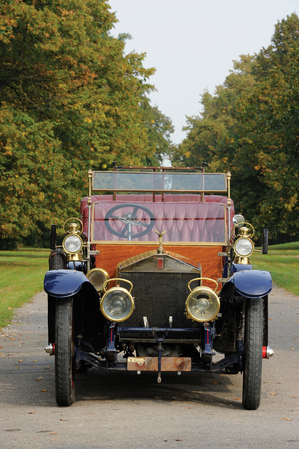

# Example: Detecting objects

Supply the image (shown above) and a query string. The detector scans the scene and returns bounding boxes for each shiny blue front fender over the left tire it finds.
[44,270,98,298]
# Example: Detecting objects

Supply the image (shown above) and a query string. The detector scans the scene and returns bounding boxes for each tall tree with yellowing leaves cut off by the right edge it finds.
[240,14,299,241]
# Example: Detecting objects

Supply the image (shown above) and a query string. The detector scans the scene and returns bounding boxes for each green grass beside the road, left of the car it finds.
[0,248,50,329]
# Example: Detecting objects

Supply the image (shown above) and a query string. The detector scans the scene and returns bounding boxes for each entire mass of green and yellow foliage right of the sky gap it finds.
[172,14,299,242]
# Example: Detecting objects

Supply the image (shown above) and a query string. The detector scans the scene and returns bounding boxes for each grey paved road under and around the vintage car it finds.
[0,289,299,449]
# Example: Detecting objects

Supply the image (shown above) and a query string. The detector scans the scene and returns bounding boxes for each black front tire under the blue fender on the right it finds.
[242,298,263,410]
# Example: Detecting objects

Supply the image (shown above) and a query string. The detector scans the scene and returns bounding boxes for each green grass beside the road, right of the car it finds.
[251,242,299,296]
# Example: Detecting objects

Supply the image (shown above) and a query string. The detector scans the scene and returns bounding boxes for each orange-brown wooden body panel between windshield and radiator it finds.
[96,244,224,280]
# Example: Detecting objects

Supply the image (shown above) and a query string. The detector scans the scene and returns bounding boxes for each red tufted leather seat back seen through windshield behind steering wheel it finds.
[83,195,227,244]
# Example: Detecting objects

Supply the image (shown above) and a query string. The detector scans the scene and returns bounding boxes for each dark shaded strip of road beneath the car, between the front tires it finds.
[76,370,242,408]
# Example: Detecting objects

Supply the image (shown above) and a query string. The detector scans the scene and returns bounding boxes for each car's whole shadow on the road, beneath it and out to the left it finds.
[0,359,242,409]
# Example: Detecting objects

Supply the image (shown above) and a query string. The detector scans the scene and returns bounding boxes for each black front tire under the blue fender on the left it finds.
[55,298,75,406]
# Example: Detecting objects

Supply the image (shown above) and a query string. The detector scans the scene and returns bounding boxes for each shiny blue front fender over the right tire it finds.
[223,270,272,298]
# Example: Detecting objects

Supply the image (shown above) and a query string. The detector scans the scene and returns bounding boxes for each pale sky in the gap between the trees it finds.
[109,0,299,144]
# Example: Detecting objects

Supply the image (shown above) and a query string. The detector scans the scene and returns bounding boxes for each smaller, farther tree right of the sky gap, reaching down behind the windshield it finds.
[173,55,262,220]
